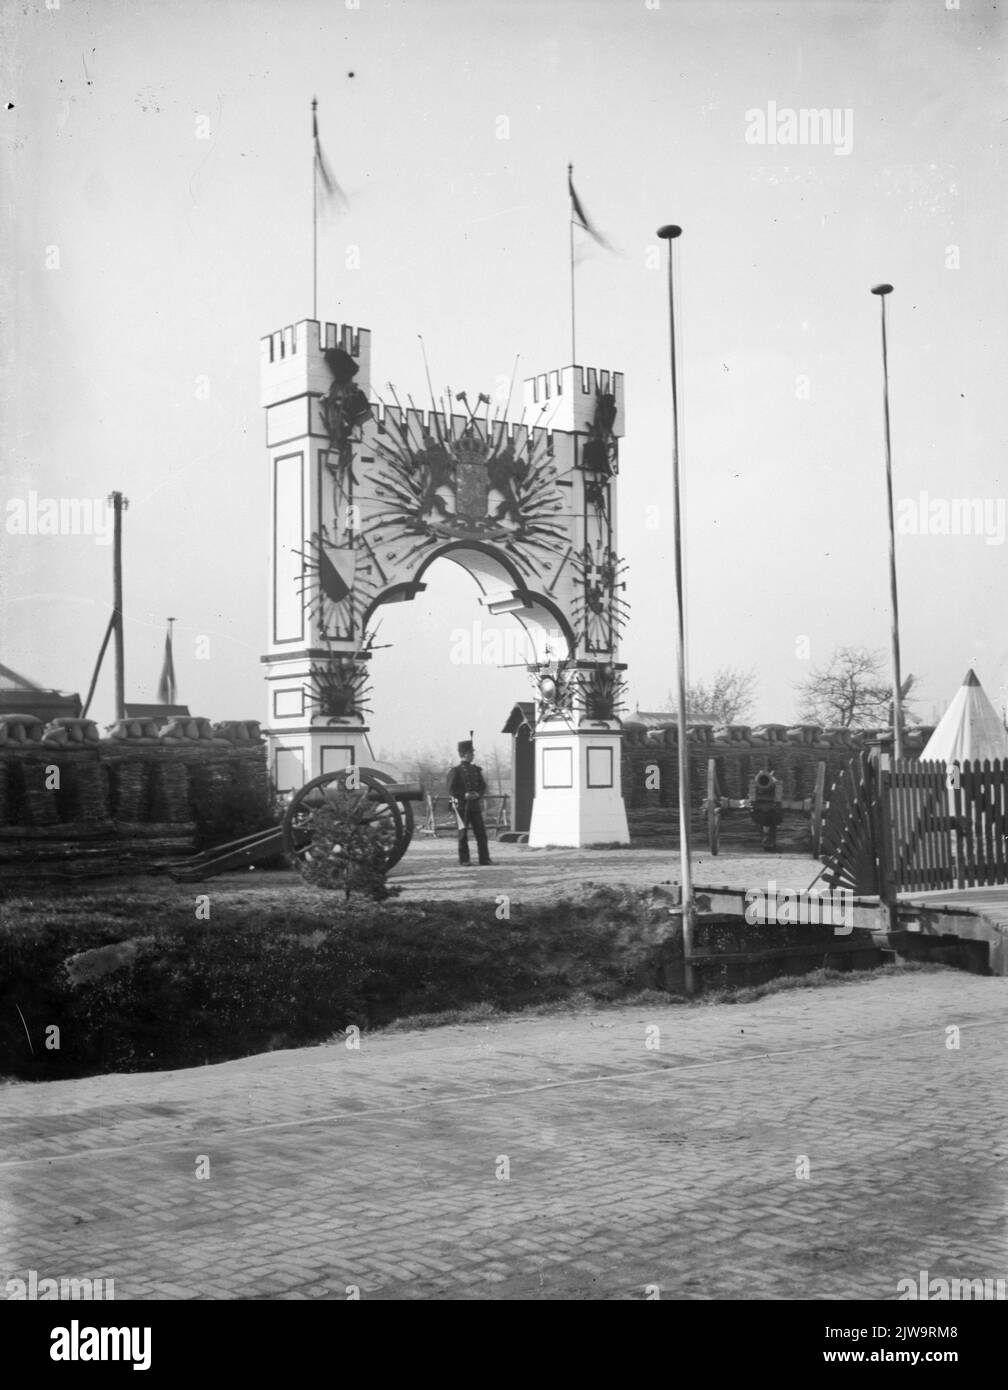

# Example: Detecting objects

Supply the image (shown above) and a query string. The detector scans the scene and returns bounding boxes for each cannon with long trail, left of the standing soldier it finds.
[168,766,424,894]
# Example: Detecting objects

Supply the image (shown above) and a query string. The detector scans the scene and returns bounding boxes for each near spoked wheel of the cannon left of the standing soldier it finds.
[282,767,413,881]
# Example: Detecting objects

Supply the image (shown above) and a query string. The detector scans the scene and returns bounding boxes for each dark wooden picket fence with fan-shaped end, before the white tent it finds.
[822,753,1008,904]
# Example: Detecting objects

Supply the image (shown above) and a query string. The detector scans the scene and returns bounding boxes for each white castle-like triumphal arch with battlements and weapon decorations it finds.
[261,320,628,845]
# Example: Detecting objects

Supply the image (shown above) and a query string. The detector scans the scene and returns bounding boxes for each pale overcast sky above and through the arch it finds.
[0,0,1008,751]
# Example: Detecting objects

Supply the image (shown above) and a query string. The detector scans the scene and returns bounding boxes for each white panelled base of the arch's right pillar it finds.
[528,721,630,849]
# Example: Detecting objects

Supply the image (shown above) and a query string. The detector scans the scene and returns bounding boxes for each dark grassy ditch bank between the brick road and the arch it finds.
[0,885,884,1080]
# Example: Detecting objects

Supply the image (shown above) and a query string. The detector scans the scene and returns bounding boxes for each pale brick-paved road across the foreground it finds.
[0,972,1008,1300]
